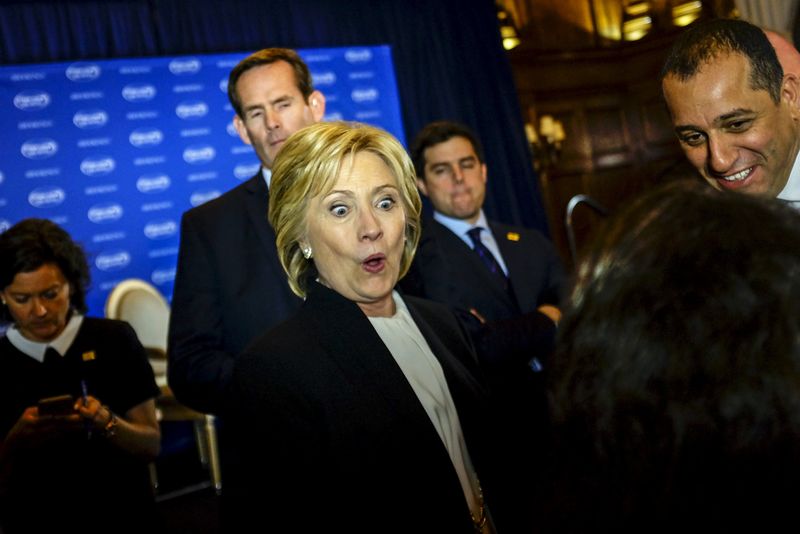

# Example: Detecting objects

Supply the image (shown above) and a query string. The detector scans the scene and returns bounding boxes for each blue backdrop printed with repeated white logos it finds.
[0,46,405,316]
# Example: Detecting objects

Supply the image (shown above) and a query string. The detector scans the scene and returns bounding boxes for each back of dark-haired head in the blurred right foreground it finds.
[550,181,800,531]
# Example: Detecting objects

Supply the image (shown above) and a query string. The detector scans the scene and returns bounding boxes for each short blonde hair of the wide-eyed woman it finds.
[269,121,422,297]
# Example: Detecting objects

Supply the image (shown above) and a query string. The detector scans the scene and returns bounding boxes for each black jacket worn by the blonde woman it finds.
[225,282,524,534]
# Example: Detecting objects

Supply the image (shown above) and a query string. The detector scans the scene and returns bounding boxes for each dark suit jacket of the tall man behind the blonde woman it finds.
[168,172,301,413]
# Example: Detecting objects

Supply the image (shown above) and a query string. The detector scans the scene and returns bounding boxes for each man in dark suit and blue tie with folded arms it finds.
[401,121,563,367]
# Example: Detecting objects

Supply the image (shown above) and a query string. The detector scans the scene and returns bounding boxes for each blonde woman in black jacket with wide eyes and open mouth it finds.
[226,122,506,533]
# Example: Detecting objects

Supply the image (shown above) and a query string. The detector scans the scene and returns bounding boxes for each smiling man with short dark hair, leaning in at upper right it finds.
[661,19,800,204]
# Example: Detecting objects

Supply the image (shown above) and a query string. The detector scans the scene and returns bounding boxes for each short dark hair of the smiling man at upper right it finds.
[661,19,783,102]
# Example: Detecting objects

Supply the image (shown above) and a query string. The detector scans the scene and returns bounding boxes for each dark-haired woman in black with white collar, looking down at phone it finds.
[0,219,160,534]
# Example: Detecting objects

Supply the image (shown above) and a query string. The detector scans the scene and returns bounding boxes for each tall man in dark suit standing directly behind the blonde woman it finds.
[168,48,325,413]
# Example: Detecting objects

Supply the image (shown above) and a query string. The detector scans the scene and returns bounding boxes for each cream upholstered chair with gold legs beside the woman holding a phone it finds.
[105,278,222,493]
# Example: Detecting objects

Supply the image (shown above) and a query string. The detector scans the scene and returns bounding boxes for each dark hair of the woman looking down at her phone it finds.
[0,219,89,323]
